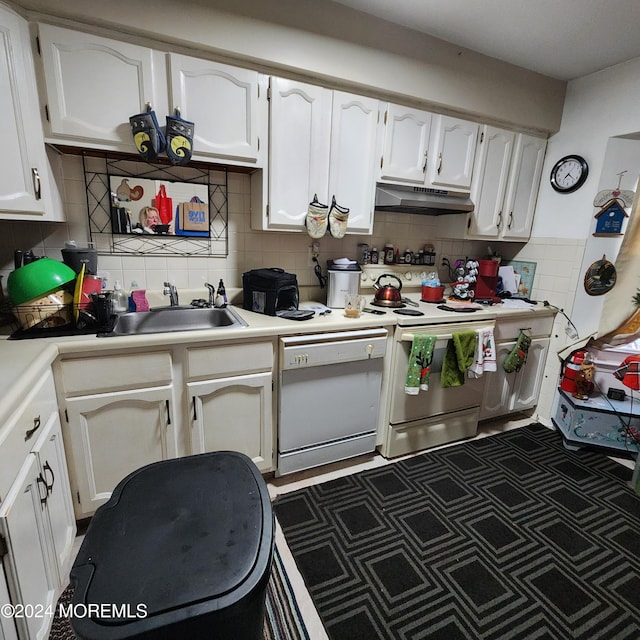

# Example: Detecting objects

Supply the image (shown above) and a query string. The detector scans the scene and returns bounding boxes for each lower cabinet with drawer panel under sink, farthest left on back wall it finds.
[55,350,178,519]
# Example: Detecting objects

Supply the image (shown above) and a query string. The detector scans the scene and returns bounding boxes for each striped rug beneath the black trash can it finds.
[49,548,310,640]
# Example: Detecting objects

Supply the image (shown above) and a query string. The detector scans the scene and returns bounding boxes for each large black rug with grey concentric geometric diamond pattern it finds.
[274,425,640,640]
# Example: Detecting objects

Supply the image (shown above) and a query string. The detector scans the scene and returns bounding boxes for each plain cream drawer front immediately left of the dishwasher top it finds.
[187,342,273,378]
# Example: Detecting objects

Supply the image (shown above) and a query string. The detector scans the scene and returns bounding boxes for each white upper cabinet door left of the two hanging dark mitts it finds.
[39,24,168,149]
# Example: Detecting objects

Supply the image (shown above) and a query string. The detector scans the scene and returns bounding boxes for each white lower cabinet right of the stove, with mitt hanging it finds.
[480,316,553,420]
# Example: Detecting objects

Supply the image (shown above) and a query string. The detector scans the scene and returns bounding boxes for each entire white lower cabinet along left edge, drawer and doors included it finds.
[0,372,76,640]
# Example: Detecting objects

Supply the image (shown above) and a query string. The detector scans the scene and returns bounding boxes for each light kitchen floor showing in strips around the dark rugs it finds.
[67,414,633,640]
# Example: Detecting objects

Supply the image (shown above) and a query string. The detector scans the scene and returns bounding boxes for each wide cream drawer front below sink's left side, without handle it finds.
[60,351,173,395]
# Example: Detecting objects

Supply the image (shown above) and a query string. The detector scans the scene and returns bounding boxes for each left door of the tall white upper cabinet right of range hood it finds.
[467,126,515,238]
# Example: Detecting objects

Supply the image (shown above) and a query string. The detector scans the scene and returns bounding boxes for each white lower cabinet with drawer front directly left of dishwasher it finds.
[186,341,274,472]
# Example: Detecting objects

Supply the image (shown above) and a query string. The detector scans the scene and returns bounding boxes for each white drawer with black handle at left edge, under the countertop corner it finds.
[0,371,58,502]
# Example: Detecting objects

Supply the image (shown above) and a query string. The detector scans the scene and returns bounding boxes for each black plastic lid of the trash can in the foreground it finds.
[71,452,273,626]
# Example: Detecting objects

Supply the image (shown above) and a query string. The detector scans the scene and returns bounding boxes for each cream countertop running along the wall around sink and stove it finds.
[0,293,555,424]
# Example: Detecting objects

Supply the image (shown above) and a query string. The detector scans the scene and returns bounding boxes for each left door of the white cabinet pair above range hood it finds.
[379,104,432,186]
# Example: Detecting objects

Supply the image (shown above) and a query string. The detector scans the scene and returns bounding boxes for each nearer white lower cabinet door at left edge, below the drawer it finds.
[0,454,57,640]
